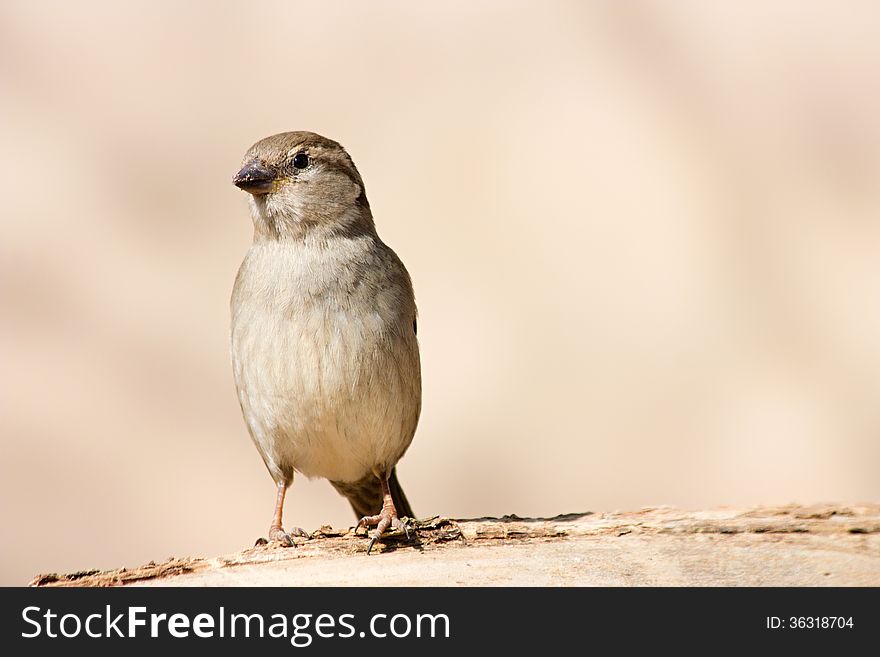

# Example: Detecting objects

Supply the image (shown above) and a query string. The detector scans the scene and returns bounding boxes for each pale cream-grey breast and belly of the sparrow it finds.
[232,240,421,481]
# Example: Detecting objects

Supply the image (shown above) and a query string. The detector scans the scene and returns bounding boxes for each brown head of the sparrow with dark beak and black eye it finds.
[232,132,373,239]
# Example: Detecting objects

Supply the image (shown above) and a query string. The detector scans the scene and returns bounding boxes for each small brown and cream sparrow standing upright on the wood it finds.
[230,131,422,554]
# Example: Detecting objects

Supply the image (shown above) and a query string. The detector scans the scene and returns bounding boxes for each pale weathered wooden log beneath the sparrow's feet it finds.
[31,504,880,586]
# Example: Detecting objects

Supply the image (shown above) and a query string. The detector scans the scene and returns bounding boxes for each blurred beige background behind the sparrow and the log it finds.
[0,0,880,584]
